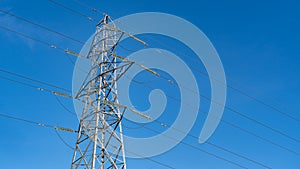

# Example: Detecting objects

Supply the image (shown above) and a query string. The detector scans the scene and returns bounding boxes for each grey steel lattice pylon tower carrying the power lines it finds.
[71,15,133,169]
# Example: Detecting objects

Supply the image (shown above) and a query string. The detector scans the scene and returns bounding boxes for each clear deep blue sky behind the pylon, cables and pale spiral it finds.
[0,0,300,169]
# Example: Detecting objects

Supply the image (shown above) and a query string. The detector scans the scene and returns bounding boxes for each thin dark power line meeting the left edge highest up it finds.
[0,9,84,44]
